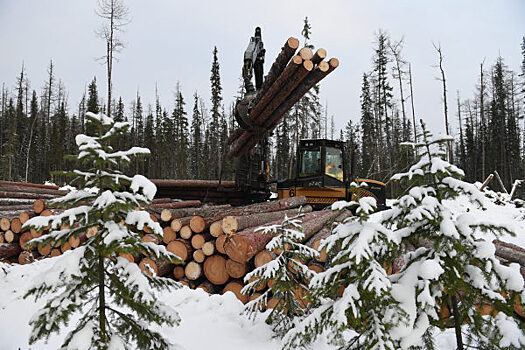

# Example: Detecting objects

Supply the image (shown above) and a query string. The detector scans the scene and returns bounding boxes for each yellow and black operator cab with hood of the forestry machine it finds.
[277,139,386,209]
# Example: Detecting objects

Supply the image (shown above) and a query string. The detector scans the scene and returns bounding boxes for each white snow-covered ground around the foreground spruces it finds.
[0,191,525,350]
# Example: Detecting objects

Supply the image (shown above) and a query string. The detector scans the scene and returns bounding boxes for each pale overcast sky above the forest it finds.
[0,0,525,135]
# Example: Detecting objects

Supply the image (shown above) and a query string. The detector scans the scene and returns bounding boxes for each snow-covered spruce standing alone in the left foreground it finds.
[24,113,180,350]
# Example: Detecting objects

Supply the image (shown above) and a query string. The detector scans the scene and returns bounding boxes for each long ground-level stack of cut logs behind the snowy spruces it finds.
[0,181,525,314]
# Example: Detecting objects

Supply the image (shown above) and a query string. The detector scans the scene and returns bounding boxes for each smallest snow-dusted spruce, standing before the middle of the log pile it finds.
[242,214,318,337]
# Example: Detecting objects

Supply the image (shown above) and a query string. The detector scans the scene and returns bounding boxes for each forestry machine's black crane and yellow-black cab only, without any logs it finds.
[229,27,386,209]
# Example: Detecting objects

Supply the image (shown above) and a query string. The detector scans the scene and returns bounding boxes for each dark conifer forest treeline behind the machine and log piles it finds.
[0,28,525,197]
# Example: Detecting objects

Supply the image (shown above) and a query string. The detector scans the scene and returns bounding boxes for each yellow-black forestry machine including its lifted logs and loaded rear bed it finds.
[154,27,386,209]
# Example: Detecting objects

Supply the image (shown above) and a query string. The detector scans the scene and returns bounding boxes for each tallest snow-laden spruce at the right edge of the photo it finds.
[383,123,525,350]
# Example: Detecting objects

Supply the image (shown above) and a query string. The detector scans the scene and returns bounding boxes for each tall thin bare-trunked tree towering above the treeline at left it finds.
[96,0,130,116]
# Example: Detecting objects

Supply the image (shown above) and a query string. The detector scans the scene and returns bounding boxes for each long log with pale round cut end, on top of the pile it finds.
[222,205,312,234]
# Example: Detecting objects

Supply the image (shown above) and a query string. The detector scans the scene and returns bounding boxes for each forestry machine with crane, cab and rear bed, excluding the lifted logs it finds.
[154,27,386,209]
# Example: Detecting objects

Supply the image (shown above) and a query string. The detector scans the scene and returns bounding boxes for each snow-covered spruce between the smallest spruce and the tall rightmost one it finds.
[284,197,405,350]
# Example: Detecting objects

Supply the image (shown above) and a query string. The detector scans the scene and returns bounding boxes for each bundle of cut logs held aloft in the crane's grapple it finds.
[227,38,339,158]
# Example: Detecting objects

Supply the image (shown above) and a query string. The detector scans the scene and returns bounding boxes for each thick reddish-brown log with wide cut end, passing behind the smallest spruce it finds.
[224,210,339,262]
